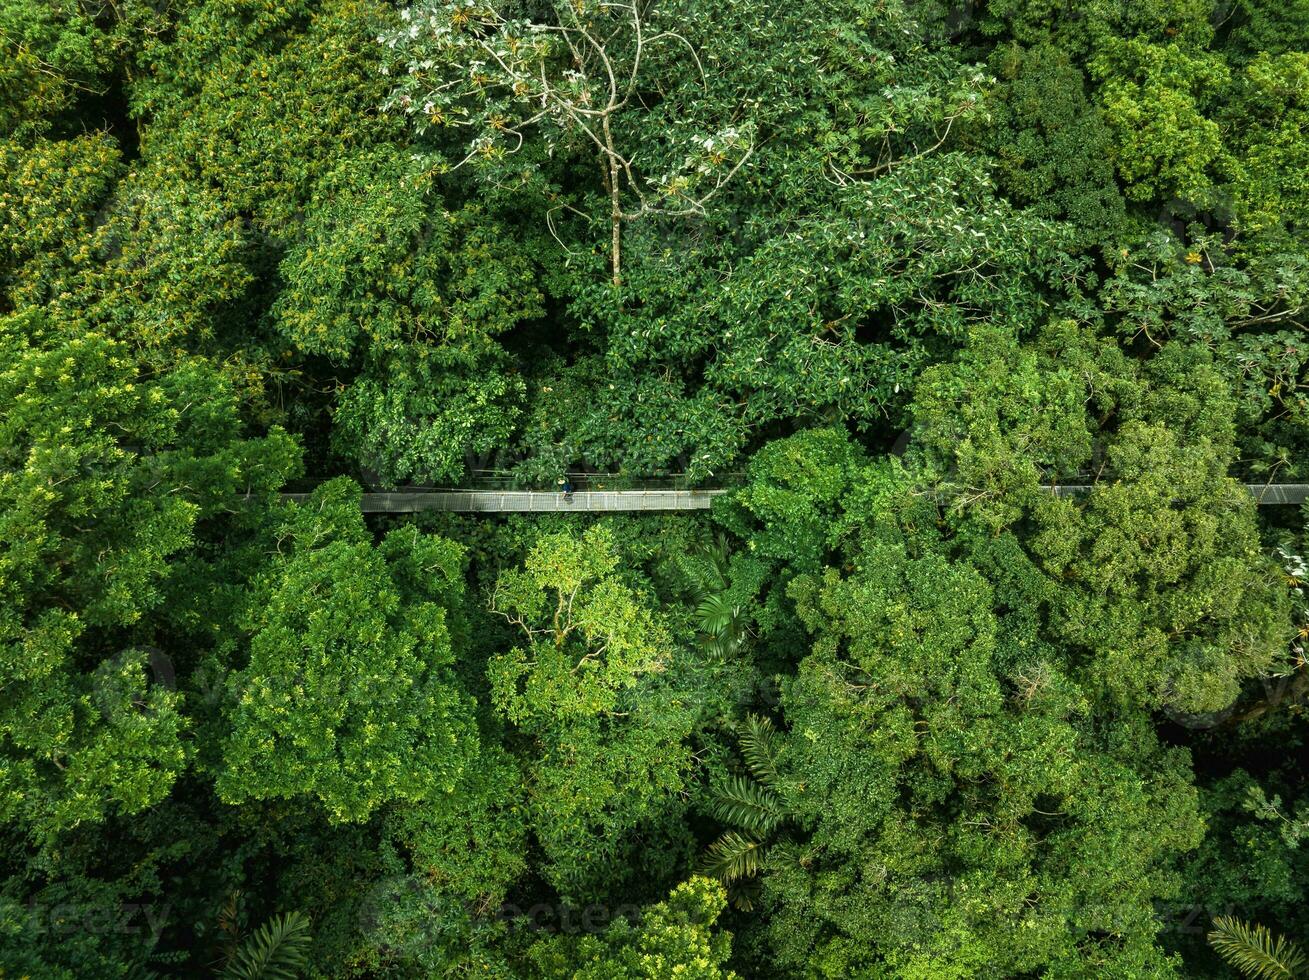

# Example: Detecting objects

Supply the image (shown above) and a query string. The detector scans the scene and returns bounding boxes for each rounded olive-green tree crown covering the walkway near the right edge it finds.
[1033,424,1291,712]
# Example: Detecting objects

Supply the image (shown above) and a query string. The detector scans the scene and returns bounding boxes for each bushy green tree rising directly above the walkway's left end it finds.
[272,145,541,484]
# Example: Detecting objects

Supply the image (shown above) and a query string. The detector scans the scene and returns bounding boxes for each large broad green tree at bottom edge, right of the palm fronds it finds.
[762,529,1203,977]
